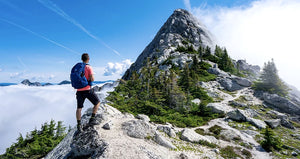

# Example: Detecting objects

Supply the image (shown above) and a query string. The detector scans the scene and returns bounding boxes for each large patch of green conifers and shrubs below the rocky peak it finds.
[107,57,218,127]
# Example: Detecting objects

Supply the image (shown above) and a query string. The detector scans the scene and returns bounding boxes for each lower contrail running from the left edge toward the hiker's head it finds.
[0,18,81,55]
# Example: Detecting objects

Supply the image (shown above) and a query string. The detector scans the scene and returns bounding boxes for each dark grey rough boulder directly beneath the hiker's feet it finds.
[69,127,108,158]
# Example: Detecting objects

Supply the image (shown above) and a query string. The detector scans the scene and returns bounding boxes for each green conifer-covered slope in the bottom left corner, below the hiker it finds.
[0,120,66,159]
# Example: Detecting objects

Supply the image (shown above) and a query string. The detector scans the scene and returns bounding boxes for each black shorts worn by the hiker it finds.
[76,90,100,108]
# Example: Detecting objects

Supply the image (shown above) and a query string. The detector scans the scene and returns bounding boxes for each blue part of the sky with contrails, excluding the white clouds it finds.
[0,0,253,82]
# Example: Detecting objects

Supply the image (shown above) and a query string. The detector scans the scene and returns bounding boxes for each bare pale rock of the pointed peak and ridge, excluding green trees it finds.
[45,9,300,159]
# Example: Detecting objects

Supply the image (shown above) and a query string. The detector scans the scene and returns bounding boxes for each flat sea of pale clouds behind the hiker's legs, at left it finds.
[0,85,96,154]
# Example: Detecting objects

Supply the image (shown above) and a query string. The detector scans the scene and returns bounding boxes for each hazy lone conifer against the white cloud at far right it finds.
[253,59,289,97]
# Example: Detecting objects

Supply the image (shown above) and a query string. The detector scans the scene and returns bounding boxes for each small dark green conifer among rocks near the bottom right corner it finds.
[260,127,282,152]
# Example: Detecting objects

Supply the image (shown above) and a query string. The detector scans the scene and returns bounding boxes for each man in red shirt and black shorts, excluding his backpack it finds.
[71,53,100,132]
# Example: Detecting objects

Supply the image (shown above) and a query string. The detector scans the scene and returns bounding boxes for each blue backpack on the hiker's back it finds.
[70,62,89,89]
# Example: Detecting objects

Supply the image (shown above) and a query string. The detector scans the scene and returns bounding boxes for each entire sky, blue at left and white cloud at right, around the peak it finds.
[0,0,300,88]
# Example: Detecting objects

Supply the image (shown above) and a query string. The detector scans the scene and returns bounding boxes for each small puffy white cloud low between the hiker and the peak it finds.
[104,59,132,76]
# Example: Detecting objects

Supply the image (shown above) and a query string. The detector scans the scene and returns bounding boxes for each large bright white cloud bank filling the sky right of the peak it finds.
[192,0,300,89]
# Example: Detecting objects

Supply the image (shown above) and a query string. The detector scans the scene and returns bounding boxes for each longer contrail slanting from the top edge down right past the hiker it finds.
[38,0,121,56]
